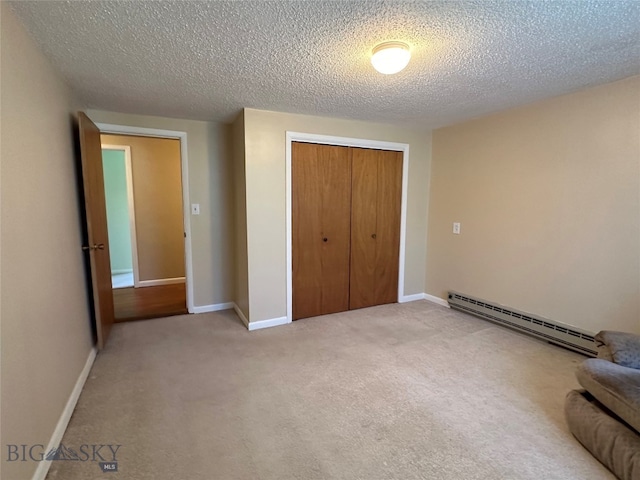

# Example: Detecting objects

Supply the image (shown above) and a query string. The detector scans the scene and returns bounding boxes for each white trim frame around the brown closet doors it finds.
[285,131,409,323]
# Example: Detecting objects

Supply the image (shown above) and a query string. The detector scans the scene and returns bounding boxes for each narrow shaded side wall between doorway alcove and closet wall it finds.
[232,112,249,319]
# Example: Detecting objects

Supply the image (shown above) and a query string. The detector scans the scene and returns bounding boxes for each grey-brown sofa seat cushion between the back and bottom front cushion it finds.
[576,358,640,432]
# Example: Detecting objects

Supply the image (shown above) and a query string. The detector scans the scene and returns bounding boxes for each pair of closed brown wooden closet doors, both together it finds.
[291,142,402,320]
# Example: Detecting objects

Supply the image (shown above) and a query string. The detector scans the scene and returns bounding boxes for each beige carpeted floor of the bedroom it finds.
[47,301,613,480]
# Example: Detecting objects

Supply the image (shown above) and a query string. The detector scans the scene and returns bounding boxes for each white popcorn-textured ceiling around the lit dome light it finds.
[12,0,640,128]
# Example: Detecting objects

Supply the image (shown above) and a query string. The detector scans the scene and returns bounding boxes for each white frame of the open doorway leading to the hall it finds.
[96,123,193,313]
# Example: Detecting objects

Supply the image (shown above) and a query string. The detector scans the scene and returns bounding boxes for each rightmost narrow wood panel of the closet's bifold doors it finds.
[375,151,402,305]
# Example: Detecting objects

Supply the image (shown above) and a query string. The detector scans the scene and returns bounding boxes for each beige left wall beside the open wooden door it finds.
[0,2,95,479]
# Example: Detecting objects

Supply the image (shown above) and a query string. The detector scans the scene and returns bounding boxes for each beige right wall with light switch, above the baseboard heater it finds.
[427,77,640,333]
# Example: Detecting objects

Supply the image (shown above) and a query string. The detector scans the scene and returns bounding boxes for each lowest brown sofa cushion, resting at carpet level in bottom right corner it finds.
[565,390,640,480]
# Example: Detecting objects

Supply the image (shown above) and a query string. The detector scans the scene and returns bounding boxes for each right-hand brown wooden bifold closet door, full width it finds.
[349,148,402,309]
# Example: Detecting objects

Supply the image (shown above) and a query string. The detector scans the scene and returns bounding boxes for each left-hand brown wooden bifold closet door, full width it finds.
[291,142,351,320]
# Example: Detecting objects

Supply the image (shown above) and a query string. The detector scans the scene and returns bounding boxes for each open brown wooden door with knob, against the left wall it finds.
[78,112,114,350]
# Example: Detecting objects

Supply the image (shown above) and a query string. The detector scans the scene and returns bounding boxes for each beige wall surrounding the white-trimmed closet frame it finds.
[244,109,431,321]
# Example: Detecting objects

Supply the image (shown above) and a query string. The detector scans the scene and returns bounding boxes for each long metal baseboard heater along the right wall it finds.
[449,292,598,357]
